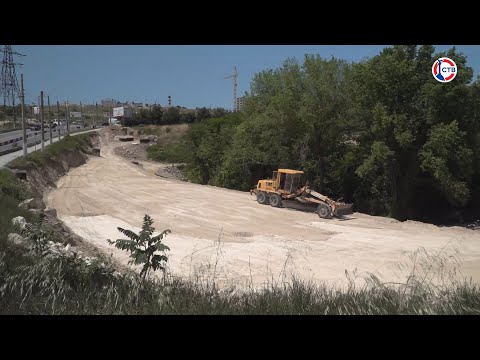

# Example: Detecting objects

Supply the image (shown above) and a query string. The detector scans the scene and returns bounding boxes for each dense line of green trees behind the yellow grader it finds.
[169,46,480,223]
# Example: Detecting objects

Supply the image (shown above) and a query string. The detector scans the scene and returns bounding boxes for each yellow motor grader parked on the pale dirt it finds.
[250,169,353,219]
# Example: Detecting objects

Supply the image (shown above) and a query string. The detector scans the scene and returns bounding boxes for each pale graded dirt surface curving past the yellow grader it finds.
[47,133,480,286]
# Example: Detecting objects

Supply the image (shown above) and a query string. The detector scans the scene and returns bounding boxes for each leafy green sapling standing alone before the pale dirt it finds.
[107,215,171,280]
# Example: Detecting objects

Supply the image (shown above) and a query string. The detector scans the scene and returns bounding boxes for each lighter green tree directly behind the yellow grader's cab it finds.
[216,55,354,195]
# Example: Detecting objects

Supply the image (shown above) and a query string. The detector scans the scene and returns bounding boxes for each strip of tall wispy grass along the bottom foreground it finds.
[0,242,480,315]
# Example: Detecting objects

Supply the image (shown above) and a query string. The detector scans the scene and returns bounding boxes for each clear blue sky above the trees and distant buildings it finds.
[13,45,480,108]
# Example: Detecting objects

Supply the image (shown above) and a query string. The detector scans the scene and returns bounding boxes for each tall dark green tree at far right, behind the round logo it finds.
[352,45,478,220]
